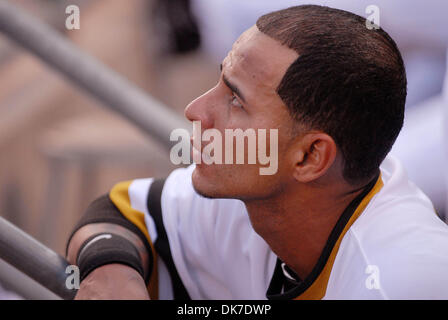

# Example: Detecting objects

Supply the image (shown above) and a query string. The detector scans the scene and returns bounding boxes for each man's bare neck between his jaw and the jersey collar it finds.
[245,180,364,279]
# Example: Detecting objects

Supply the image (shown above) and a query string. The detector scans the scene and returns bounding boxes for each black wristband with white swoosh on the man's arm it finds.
[76,233,146,281]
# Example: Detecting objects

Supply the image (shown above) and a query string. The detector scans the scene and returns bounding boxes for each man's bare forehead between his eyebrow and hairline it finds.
[223,26,298,91]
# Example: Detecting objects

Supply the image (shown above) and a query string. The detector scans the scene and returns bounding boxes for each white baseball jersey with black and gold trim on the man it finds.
[110,157,448,299]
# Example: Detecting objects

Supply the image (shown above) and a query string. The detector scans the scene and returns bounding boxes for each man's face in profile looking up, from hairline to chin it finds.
[185,26,298,200]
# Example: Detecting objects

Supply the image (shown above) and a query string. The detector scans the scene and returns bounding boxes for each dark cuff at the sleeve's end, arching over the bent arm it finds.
[66,194,154,283]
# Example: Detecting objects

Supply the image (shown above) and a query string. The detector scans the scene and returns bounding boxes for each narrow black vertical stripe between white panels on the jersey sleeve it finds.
[148,179,191,300]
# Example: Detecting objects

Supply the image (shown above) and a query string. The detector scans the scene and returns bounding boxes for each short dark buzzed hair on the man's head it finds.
[257,5,406,184]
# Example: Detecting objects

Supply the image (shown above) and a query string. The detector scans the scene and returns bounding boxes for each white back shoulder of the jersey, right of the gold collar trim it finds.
[335,158,448,299]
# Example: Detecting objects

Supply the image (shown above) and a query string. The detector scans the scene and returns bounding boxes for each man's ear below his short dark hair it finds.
[293,132,337,183]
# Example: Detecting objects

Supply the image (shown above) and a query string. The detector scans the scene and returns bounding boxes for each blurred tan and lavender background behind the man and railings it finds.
[0,0,448,300]
